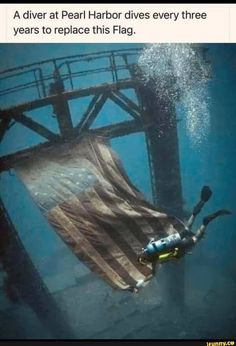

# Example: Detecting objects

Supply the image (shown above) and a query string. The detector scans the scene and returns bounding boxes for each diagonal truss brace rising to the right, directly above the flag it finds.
[76,93,108,134]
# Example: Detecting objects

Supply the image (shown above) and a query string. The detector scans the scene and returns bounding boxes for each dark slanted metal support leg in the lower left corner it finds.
[0,199,74,339]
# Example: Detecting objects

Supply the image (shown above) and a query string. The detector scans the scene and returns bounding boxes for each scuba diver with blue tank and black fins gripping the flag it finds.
[134,186,231,292]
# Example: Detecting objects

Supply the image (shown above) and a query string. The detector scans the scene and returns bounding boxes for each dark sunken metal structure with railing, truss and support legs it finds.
[0,49,187,338]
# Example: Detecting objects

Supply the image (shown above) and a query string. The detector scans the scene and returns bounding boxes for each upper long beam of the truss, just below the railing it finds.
[0,79,135,119]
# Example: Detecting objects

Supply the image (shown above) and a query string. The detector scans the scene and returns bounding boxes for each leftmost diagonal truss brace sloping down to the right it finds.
[12,113,57,141]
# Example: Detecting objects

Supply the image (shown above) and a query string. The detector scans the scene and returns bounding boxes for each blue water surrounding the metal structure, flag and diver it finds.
[0,44,236,339]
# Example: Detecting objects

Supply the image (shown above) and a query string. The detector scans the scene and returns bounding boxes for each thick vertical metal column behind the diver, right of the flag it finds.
[136,78,185,308]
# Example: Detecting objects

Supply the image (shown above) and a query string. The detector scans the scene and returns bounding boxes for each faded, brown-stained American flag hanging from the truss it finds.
[14,135,179,289]
